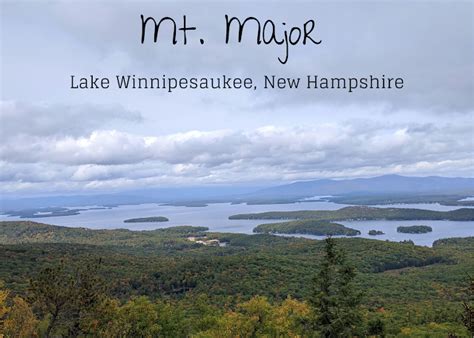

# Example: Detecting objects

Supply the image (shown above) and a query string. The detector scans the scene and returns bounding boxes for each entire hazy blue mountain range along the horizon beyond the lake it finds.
[0,175,474,211]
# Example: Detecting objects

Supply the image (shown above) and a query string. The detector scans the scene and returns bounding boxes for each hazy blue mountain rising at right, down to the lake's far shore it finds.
[241,175,474,205]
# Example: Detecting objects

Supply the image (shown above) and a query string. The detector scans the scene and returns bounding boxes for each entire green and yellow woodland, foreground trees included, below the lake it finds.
[0,222,474,337]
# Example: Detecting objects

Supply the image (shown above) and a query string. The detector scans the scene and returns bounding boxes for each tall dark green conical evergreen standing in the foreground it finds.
[310,237,362,338]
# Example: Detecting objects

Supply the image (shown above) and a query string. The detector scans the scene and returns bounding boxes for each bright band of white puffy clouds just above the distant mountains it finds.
[0,120,474,193]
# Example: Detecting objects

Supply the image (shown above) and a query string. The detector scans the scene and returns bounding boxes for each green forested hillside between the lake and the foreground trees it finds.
[0,222,474,337]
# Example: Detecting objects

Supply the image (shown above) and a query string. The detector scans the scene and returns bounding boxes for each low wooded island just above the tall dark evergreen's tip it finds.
[253,219,360,236]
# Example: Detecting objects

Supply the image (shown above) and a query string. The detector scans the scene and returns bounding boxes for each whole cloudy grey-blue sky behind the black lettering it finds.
[0,0,474,195]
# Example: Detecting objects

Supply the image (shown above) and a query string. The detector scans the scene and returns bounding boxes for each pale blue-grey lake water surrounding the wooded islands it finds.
[0,202,474,246]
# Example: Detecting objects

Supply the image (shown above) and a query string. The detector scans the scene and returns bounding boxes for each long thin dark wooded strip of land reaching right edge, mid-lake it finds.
[229,206,474,221]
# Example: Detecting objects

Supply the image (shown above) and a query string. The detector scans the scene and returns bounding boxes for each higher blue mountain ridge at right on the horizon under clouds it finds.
[241,175,474,199]
